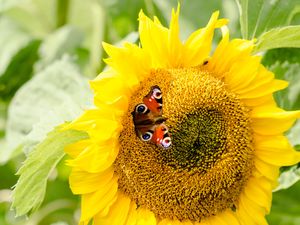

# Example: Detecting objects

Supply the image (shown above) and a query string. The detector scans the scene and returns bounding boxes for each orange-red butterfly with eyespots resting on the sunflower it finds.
[131,85,172,148]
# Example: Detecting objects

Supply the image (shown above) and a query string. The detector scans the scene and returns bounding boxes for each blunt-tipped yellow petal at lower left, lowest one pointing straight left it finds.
[69,167,114,194]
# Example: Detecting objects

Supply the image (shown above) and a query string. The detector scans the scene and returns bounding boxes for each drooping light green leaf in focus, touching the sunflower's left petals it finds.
[12,128,88,216]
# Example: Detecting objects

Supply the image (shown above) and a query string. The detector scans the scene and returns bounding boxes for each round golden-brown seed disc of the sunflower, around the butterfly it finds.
[115,68,253,221]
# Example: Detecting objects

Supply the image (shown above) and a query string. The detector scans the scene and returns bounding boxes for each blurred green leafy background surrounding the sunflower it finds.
[0,0,300,225]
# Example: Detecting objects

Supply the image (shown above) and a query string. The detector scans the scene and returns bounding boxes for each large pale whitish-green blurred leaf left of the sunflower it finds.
[1,58,92,161]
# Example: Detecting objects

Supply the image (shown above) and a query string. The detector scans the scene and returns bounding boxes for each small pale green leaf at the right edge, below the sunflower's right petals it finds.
[274,166,300,191]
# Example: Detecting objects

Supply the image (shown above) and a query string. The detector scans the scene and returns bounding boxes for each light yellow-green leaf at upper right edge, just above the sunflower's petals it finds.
[254,26,300,52]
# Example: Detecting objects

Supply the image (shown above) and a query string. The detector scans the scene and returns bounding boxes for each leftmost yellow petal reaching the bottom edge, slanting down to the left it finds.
[80,176,118,221]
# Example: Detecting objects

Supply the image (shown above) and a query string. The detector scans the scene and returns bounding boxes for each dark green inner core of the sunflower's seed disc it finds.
[161,108,226,172]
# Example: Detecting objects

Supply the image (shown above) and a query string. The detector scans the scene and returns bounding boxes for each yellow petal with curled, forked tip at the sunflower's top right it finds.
[183,12,228,67]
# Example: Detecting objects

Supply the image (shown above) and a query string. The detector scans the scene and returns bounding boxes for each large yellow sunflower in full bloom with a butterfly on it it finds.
[66,7,300,225]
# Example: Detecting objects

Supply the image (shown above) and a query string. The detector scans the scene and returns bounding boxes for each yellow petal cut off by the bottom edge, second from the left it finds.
[94,192,131,225]
